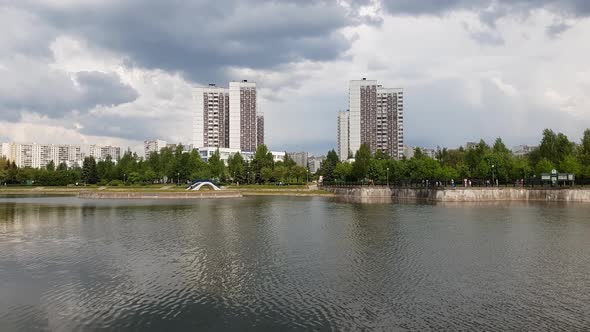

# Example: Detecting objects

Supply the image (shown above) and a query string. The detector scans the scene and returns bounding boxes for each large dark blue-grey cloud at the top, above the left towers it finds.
[10,0,374,82]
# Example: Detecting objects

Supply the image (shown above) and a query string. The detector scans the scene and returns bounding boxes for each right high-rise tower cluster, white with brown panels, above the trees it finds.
[338,78,404,160]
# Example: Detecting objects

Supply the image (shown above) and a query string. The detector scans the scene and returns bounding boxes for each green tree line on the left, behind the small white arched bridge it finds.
[0,144,309,186]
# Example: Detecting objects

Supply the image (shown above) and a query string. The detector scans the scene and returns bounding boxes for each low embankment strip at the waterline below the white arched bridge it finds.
[78,190,242,199]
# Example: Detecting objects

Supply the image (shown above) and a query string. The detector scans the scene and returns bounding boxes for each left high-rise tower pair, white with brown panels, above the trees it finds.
[193,80,264,151]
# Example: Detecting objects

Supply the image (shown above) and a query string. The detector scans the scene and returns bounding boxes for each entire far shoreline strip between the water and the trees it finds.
[0,187,590,203]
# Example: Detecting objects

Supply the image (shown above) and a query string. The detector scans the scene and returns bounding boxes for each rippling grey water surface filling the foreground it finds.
[0,197,590,331]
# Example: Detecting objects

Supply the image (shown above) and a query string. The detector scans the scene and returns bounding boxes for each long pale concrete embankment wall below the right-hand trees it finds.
[324,187,590,203]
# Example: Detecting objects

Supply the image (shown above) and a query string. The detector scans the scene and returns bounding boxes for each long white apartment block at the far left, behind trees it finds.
[2,142,83,168]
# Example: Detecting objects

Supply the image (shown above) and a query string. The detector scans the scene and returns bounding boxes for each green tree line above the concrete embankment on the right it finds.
[318,129,590,184]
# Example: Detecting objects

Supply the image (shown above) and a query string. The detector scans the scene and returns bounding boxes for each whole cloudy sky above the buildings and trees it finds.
[0,0,590,155]
